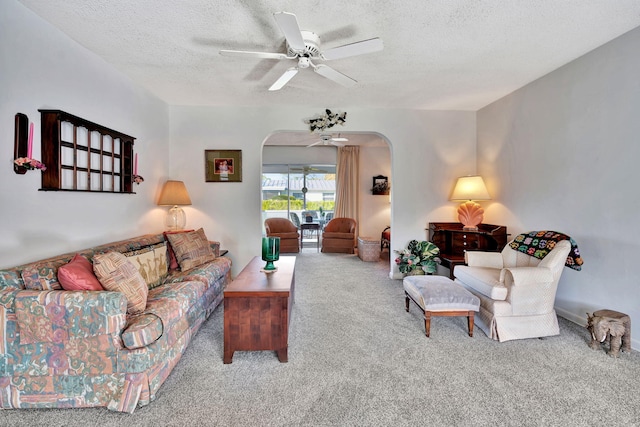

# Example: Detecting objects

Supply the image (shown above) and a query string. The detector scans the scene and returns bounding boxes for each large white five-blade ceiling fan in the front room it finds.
[220,12,383,91]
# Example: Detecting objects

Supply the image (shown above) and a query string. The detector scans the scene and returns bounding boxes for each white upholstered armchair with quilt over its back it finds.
[454,240,571,342]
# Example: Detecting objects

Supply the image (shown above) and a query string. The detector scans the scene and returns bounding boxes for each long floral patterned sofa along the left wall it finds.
[0,232,231,413]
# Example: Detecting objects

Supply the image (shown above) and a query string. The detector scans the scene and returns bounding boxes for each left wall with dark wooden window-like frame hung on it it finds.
[0,0,170,268]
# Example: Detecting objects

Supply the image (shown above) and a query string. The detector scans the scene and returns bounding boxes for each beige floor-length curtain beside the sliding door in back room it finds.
[333,145,360,224]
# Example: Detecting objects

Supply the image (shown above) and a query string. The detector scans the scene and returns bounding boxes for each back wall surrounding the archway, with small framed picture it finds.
[170,106,476,274]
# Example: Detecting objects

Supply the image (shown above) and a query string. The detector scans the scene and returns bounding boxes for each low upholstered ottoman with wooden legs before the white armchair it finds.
[402,276,480,337]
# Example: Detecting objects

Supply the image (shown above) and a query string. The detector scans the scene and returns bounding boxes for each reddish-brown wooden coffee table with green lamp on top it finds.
[223,256,296,363]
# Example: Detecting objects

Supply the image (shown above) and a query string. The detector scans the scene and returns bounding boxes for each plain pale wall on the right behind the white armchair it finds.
[478,25,640,349]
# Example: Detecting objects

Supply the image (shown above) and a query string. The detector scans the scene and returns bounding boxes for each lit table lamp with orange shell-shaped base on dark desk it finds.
[449,175,491,231]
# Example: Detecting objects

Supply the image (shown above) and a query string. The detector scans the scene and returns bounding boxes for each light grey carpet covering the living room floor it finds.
[0,253,640,427]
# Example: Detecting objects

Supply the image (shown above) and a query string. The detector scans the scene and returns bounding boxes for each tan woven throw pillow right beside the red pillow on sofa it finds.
[93,252,149,314]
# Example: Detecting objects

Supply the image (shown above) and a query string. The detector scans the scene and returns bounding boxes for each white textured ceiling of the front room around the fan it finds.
[19,0,640,110]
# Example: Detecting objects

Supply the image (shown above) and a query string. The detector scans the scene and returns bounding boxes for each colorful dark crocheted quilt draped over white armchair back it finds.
[510,230,583,271]
